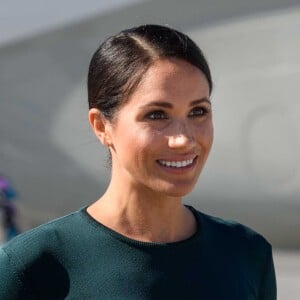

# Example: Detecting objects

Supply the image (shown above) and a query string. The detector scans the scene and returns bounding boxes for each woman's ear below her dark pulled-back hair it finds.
[89,108,111,146]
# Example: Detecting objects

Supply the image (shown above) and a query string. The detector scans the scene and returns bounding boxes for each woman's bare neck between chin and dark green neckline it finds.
[88,179,196,243]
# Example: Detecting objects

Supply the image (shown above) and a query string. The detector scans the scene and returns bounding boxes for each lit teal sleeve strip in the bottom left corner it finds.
[0,248,25,300]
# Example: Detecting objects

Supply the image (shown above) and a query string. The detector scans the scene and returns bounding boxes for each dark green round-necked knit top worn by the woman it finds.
[0,206,276,300]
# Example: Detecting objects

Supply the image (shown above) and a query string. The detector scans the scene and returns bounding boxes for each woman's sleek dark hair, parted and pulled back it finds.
[88,25,213,120]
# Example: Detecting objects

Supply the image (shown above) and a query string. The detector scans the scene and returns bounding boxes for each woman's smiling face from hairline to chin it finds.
[109,59,213,197]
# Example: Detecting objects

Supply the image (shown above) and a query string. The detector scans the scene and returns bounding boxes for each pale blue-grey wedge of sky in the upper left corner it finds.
[0,0,145,47]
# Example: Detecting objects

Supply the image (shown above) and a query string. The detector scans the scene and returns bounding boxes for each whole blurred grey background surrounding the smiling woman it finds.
[0,0,300,299]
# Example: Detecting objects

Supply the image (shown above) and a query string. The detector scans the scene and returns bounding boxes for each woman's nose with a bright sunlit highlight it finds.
[168,124,195,148]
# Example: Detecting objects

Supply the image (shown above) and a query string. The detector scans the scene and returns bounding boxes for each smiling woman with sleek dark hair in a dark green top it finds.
[0,25,276,300]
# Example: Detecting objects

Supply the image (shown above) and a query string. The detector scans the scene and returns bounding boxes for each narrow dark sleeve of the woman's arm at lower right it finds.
[259,245,277,300]
